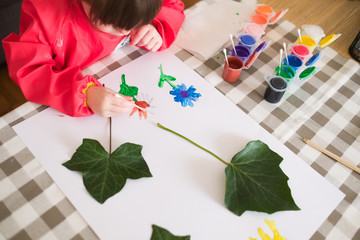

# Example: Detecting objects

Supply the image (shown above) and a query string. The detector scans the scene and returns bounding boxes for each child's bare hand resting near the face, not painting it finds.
[130,24,162,52]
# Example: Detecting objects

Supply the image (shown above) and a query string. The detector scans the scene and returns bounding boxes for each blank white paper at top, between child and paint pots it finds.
[175,0,256,60]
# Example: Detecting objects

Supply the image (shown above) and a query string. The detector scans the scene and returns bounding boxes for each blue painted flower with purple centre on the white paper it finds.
[170,84,201,107]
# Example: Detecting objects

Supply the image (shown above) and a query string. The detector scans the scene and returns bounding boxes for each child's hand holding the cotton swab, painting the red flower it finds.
[86,86,134,117]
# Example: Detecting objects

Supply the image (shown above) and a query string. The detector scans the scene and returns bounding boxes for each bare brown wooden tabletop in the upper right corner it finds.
[256,0,360,58]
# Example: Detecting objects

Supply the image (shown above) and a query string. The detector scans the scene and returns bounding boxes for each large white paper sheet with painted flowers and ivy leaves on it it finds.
[14,51,344,240]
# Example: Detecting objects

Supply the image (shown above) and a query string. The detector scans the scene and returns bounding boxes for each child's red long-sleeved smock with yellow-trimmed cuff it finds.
[3,0,184,116]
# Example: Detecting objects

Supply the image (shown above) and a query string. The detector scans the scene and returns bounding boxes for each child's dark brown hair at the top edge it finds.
[85,0,162,30]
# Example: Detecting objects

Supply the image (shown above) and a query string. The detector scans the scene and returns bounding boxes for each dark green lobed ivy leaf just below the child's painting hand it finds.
[63,139,152,203]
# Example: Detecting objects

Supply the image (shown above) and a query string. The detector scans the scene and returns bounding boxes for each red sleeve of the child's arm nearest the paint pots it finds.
[153,0,185,51]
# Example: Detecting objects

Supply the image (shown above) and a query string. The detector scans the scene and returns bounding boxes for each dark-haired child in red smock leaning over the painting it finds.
[3,0,184,117]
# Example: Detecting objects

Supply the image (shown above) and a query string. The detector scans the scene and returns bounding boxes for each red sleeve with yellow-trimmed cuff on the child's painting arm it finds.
[3,0,101,116]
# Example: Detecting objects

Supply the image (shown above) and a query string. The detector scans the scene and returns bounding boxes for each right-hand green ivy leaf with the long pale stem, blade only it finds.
[225,140,299,216]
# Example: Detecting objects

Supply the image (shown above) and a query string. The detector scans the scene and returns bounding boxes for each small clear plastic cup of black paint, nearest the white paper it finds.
[264,76,288,103]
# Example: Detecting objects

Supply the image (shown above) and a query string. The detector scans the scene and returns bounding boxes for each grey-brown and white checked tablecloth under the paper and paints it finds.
[0,4,360,240]
